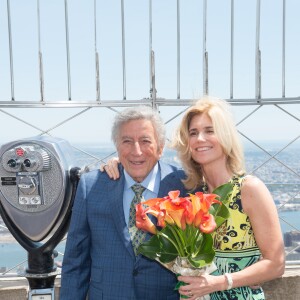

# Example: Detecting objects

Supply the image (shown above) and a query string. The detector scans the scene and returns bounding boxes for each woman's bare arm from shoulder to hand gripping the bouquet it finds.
[178,176,285,300]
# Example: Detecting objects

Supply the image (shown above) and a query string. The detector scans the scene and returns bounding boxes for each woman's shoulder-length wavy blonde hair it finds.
[171,96,245,190]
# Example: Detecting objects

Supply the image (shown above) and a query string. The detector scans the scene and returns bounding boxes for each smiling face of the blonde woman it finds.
[189,113,226,167]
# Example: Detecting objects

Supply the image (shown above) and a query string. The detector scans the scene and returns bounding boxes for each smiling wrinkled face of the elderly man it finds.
[117,120,163,182]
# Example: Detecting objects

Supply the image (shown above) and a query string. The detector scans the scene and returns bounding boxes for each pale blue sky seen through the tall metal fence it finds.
[0,0,300,146]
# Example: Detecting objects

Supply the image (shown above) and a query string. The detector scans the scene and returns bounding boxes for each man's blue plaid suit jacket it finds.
[60,162,186,300]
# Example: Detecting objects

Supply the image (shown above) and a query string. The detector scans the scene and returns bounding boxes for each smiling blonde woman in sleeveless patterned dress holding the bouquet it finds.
[173,97,285,300]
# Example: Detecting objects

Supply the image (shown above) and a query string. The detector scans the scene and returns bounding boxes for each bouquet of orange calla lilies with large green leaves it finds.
[136,183,233,282]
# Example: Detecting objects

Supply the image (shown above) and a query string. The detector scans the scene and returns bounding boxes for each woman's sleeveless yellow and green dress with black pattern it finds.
[210,176,265,300]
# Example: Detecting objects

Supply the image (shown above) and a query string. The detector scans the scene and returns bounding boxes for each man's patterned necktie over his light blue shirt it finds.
[128,184,147,255]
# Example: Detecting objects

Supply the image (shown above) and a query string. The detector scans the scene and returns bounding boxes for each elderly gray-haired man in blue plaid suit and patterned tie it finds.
[60,106,186,300]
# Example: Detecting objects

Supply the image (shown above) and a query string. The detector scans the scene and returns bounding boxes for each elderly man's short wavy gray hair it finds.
[111,105,166,148]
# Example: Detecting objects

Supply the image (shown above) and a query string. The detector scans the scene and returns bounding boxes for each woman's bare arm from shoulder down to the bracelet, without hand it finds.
[233,176,285,286]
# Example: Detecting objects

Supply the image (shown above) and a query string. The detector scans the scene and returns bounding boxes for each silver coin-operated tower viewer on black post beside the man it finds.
[0,137,80,300]
